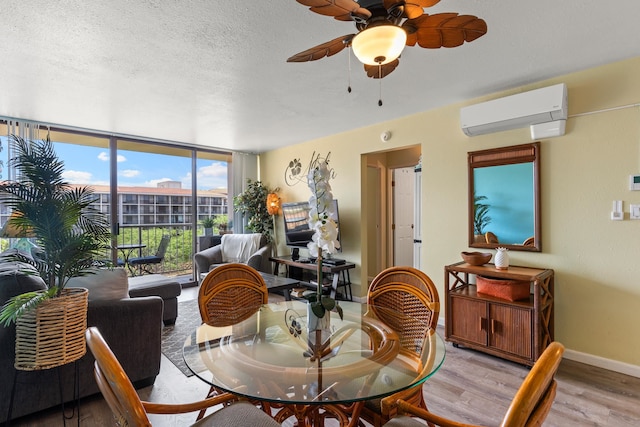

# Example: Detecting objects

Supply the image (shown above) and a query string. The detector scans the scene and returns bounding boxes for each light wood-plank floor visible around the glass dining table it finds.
[12,288,640,427]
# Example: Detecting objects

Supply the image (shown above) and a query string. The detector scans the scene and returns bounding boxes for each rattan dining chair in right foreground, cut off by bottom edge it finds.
[385,341,564,427]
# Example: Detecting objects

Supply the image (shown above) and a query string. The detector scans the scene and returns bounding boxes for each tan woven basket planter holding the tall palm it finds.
[14,288,89,371]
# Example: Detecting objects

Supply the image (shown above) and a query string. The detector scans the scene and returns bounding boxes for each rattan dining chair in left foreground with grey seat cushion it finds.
[85,327,280,427]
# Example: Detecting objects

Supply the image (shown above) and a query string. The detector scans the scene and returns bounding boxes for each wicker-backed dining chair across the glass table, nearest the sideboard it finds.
[360,267,440,427]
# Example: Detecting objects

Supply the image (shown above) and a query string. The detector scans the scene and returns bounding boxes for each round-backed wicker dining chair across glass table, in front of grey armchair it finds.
[197,263,269,419]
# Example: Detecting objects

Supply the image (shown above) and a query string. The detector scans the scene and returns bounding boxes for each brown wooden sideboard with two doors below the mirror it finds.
[445,262,554,366]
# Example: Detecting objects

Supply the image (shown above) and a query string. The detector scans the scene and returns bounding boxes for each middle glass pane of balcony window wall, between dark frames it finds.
[116,139,193,273]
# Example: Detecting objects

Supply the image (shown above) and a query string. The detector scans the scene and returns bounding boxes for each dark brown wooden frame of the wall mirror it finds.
[467,142,542,252]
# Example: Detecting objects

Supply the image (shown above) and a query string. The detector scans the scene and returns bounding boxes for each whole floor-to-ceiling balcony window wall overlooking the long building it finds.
[0,122,231,280]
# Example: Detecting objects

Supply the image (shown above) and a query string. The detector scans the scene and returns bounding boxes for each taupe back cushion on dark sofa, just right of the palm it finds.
[67,268,129,301]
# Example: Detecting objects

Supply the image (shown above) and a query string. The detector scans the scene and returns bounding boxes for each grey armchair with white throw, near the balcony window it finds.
[193,233,272,281]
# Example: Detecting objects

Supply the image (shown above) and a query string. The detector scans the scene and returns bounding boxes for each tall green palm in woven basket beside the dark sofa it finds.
[0,136,110,369]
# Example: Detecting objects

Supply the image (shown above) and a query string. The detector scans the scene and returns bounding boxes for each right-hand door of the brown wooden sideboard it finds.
[489,304,533,359]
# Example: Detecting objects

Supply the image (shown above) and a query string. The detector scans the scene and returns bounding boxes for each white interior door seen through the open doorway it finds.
[393,168,415,266]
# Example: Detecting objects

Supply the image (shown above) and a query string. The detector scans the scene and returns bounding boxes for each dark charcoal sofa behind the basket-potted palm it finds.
[0,255,163,423]
